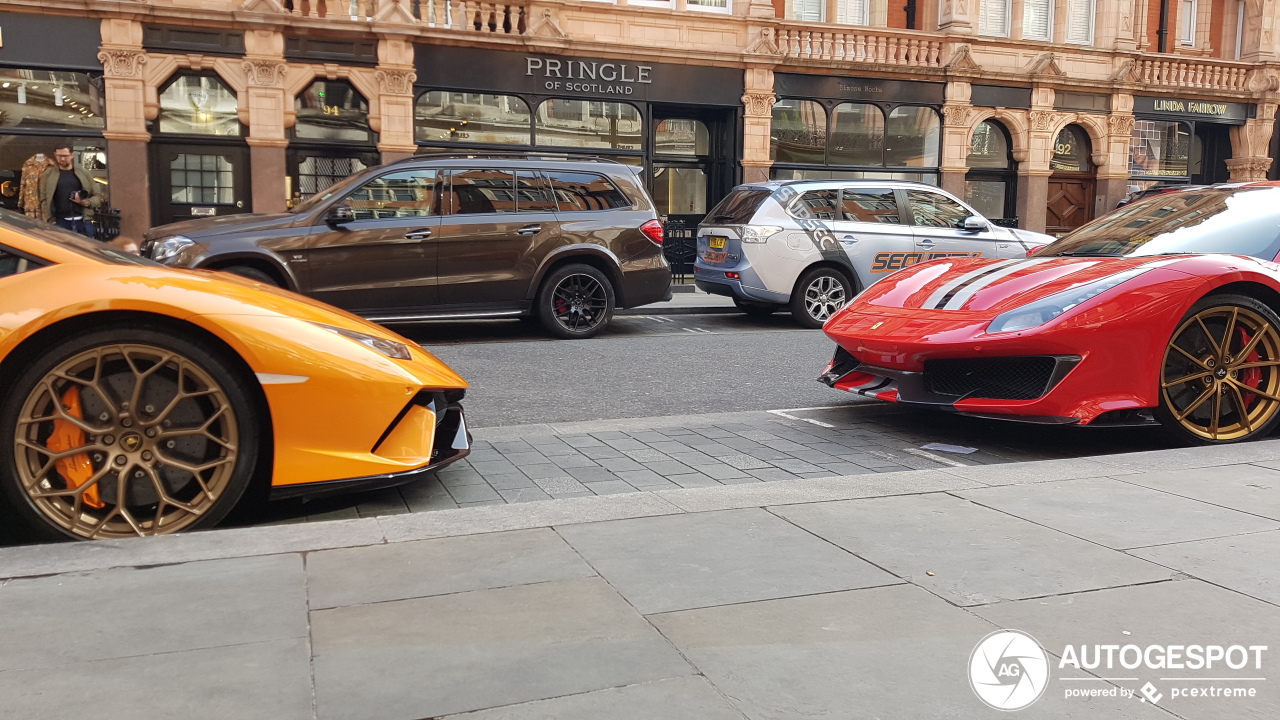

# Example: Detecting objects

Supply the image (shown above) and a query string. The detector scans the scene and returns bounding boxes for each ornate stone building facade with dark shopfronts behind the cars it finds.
[0,0,1280,234]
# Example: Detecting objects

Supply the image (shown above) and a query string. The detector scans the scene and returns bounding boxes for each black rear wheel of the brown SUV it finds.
[534,263,617,340]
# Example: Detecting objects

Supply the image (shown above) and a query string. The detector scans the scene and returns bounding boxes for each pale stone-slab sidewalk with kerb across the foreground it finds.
[0,441,1280,720]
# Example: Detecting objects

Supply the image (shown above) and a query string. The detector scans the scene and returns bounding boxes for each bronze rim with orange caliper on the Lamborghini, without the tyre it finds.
[13,342,243,539]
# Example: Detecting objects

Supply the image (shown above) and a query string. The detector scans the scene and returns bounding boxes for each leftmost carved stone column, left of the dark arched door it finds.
[97,19,151,242]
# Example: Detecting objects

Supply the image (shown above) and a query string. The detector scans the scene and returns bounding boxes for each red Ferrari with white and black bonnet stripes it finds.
[819,183,1280,445]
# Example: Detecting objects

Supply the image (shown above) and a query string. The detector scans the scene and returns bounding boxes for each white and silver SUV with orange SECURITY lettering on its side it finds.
[694,181,1055,328]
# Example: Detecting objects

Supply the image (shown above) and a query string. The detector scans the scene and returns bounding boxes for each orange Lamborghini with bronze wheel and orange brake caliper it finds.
[0,210,470,539]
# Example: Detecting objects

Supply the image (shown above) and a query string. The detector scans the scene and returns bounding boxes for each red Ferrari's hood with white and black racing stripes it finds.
[854,258,1175,315]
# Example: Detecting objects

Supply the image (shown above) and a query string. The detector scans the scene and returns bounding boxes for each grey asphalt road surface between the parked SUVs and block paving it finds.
[397,314,868,428]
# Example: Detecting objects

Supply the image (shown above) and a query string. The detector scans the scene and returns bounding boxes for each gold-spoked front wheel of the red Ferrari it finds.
[1156,295,1280,445]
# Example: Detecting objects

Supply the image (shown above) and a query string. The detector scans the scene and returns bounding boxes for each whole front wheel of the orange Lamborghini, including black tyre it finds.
[0,327,260,539]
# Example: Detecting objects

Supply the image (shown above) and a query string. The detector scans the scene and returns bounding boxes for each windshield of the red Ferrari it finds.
[1036,187,1280,260]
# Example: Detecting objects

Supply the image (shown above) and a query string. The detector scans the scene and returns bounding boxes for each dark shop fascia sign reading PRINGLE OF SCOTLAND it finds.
[416,45,744,106]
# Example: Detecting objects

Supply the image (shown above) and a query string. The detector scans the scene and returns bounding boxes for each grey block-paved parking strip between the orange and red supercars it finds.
[271,400,1172,523]
